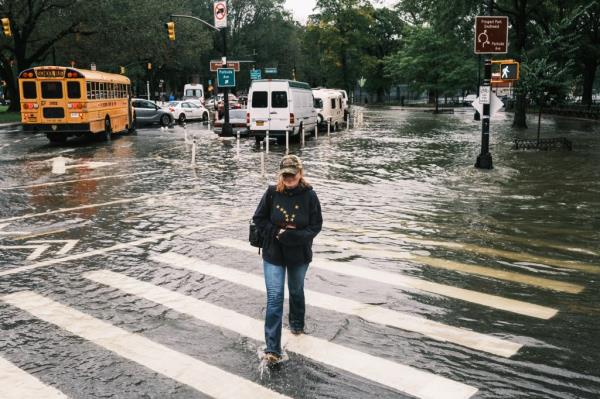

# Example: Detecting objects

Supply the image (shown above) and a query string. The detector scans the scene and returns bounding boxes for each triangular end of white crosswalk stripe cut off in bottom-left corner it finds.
[0,357,67,399]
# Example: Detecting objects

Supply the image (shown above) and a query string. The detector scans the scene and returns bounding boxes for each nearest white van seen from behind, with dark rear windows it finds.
[247,79,317,143]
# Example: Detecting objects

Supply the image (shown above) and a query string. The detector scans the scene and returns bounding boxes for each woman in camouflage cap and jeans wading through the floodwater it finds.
[252,155,323,365]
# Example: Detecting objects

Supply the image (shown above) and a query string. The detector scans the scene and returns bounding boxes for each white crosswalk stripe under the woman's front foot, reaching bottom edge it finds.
[84,270,477,399]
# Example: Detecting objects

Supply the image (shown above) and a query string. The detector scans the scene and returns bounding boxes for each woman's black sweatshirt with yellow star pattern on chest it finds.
[252,186,323,267]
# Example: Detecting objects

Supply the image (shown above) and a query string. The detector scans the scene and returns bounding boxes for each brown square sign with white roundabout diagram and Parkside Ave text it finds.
[475,16,508,54]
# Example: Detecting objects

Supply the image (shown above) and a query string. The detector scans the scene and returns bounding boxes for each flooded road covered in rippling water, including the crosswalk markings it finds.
[0,108,600,399]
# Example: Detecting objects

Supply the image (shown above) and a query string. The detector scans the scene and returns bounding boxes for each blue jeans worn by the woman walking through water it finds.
[263,261,308,355]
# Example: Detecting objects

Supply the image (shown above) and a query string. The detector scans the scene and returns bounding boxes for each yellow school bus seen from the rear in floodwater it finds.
[19,66,135,143]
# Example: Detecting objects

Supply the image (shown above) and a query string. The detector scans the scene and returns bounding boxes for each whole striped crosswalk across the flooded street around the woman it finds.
[0,228,585,399]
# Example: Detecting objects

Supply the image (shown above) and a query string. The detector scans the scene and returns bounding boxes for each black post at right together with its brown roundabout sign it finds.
[474,13,508,169]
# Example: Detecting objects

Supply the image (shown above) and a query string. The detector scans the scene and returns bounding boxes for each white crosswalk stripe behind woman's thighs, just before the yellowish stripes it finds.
[211,239,558,319]
